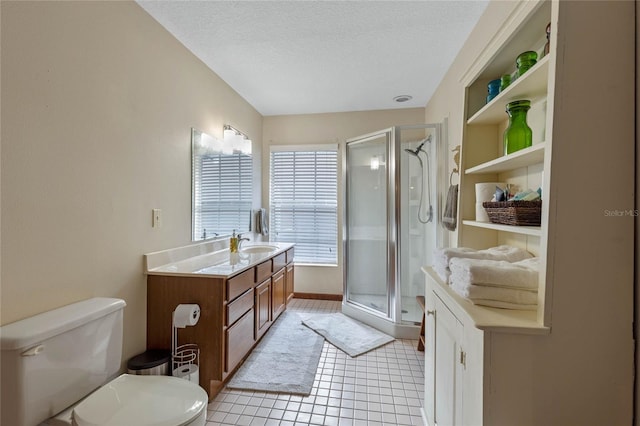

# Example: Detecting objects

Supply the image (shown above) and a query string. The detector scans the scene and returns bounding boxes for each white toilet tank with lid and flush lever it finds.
[0,297,126,426]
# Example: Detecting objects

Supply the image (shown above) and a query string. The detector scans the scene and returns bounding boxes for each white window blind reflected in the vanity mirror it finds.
[194,153,253,239]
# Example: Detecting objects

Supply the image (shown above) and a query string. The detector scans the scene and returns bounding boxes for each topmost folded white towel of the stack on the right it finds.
[433,245,533,282]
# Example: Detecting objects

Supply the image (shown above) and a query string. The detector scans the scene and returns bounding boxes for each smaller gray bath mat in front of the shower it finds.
[302,313,395,357]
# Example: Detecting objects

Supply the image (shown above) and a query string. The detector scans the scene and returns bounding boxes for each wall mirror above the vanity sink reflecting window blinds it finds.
[191,128,253,241]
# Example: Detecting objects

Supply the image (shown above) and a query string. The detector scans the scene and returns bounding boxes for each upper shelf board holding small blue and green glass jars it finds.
[467,55,549,124]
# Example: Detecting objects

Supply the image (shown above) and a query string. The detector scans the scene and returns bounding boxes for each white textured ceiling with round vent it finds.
[138,0,487,115]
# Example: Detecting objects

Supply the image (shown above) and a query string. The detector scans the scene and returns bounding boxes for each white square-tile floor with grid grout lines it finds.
[207,299,424,426]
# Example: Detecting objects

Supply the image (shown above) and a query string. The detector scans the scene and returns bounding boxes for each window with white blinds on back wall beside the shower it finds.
[270,145,338,265]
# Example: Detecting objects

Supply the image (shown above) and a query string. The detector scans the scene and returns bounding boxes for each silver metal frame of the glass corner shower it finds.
[342,120,448,327]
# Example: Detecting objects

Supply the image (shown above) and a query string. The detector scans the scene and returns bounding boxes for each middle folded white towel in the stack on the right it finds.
[449,257,539,290]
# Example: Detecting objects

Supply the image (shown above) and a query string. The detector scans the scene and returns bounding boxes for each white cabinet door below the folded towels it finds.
[432,295,464,425]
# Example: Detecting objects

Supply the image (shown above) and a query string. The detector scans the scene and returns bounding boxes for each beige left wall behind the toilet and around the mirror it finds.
[0,1,262,359]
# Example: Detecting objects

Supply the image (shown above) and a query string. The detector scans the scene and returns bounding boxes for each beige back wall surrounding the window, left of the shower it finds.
[262,108,424,295]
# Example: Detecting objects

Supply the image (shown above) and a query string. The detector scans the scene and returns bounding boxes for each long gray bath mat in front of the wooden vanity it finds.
[227,311,324,395]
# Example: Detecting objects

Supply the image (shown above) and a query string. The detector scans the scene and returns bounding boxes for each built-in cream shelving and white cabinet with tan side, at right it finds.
[423,0,637,426]
